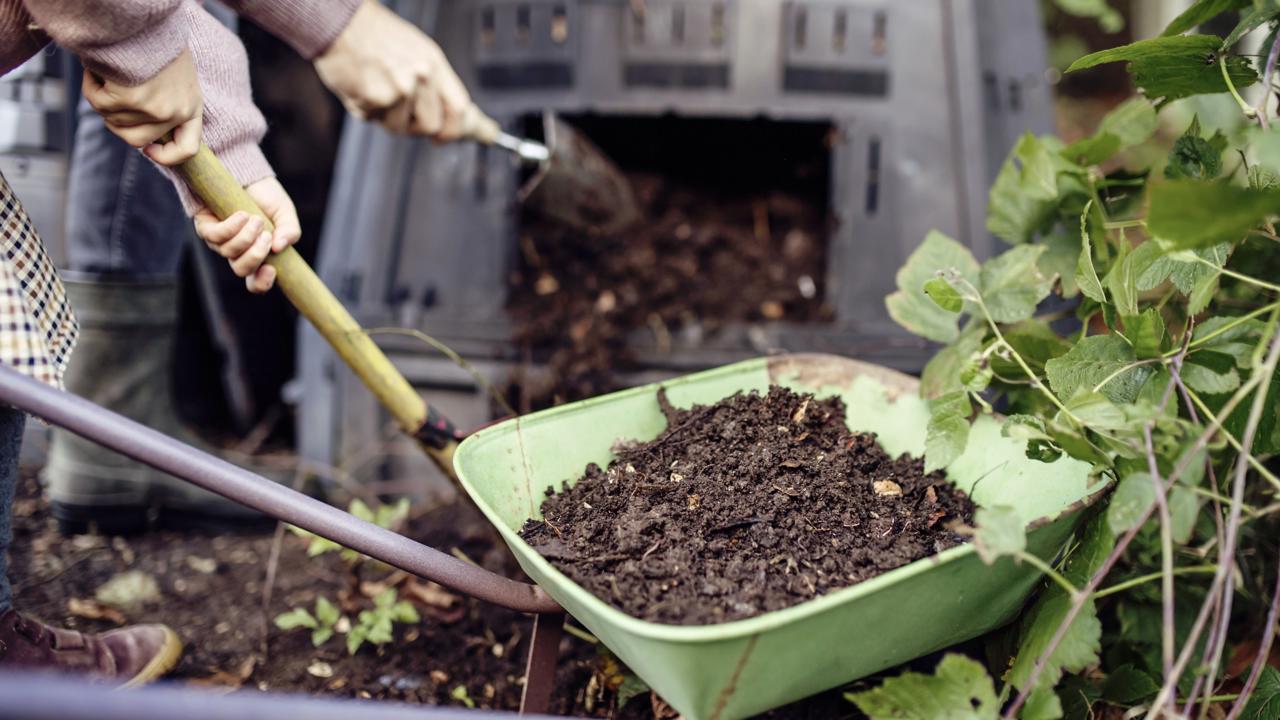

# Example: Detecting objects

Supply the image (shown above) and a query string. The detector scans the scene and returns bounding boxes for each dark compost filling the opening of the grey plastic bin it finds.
[508,173,831,411]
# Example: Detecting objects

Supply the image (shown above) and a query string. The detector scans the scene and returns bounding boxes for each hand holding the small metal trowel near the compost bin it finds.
[315,0,471,141]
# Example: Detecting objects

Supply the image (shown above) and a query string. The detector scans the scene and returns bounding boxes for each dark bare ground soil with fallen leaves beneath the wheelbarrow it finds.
[9,468,860,720]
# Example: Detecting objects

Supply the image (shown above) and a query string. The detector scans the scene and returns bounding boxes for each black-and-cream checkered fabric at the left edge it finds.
[0,169,79,388]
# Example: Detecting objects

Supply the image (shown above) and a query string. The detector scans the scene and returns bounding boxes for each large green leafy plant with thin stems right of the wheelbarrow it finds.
[850,0,1280,720]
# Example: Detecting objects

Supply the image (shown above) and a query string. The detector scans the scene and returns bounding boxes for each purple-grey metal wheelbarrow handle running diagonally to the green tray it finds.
[0,368,563,612]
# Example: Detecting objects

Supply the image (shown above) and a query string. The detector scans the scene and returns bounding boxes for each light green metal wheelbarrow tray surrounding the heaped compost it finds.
[454,355,1101,720]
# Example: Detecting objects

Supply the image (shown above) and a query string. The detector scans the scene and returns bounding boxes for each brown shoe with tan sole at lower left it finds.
[0,610,182,688]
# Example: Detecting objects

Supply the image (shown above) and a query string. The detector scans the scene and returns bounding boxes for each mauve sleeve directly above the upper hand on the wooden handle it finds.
[24,0,187,85]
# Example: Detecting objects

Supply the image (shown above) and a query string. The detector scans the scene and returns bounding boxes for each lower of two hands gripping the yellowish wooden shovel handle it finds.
[193,178,302,292]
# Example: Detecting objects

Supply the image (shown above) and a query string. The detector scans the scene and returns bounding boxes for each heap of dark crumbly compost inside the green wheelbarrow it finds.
[522,387,974,625]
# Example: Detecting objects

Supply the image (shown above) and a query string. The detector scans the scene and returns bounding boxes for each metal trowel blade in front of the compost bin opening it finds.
[518,113,640,234]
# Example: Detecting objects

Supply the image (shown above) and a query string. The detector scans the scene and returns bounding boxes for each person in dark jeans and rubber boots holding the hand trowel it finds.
[41,0,470,534]
